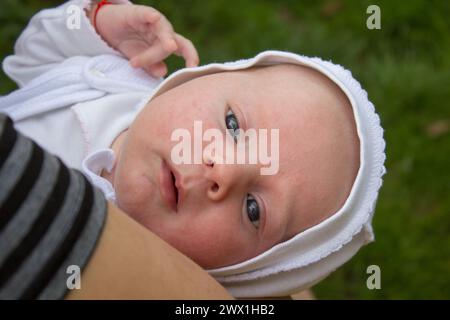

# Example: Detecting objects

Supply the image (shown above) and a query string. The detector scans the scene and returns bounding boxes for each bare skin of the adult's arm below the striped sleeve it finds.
[67,204,231,299]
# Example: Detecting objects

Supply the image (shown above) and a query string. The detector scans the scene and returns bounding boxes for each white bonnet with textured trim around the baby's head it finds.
[148,50,386,298]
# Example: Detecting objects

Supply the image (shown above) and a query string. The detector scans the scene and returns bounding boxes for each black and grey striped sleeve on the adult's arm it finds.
[0,113,106,299]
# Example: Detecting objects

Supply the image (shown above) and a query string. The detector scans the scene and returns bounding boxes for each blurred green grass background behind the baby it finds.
[0,0,450,299]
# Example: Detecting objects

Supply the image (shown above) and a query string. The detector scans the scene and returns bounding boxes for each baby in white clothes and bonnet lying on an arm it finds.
[0,0,385,297]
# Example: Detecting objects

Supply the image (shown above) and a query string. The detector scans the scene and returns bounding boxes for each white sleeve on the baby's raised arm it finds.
[3,0,130,87]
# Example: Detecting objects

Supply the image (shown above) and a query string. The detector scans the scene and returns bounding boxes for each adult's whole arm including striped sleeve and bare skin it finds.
[0,114,229,299]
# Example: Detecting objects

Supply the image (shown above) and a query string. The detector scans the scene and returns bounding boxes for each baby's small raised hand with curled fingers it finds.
[89,4,199,77]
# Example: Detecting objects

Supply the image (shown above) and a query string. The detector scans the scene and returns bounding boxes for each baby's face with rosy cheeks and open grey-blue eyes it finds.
[109,65,359,269]
